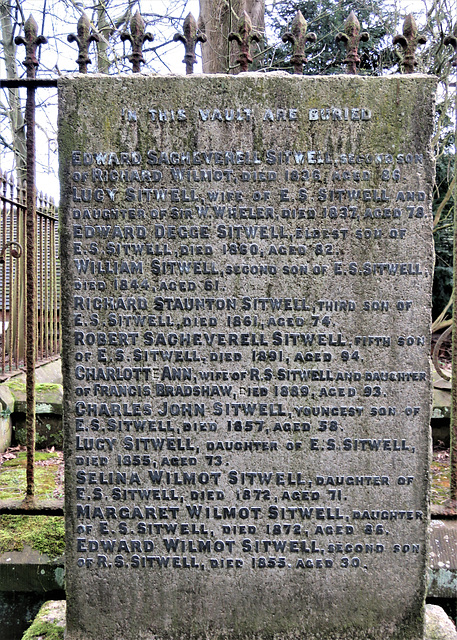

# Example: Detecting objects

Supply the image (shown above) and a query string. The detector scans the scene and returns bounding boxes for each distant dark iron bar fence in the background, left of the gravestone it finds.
[0,169,60,379]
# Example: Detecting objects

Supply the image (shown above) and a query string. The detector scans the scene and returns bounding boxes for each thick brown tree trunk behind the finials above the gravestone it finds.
[200,0,265,73]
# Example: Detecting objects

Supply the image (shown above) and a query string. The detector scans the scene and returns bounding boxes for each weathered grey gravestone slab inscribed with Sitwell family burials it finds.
[59,74,435,640]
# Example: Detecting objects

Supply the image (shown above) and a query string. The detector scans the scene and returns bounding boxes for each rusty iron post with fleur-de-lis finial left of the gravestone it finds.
[15,15,47,503]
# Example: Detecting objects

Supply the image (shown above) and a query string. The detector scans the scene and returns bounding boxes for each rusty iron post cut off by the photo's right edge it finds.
[444,23,457,501]
